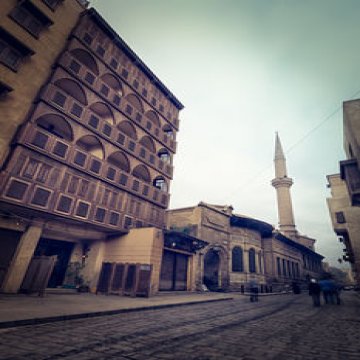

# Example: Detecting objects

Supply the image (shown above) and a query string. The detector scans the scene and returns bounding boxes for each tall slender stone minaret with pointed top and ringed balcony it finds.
[271,133,297,239]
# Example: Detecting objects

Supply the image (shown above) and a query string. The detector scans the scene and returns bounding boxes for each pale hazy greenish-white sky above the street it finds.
[91,0,360,265]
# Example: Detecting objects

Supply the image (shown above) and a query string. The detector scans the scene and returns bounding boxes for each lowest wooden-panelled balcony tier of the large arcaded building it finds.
[0,147,167,232]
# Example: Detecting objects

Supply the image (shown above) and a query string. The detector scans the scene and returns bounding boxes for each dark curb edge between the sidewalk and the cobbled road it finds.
[0,297,234,329]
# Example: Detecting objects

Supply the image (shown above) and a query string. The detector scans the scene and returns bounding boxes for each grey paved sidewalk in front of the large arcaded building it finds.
[0,292,234,328]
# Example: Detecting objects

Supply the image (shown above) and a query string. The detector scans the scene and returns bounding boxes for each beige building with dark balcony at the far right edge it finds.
[327,99,360,285]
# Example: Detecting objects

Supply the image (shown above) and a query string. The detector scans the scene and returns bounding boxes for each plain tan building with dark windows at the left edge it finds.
[0,0,86,289]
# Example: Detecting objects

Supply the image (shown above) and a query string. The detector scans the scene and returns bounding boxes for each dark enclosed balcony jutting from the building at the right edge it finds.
[340,159,360,206]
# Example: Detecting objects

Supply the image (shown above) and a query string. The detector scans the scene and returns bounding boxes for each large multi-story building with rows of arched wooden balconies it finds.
[0,1,183,292]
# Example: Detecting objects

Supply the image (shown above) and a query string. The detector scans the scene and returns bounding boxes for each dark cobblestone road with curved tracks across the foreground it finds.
[0,292,360,360]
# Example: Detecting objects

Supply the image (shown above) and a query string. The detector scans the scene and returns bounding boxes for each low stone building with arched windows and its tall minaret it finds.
[167,135,323,292]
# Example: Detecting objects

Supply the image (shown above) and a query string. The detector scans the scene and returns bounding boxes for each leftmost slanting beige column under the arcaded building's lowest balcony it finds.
[1,222,43,293]
